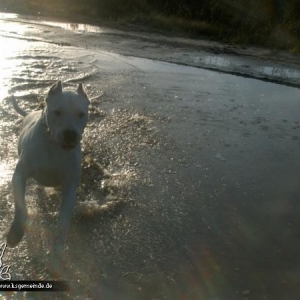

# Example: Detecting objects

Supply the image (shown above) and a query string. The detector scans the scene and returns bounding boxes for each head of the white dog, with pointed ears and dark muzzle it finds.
[44,81,90,150]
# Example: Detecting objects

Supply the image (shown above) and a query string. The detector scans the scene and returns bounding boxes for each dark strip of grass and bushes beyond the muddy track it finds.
[0,0,300,53]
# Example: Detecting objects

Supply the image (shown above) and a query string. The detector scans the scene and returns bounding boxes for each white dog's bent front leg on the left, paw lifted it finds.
[7,162,28,247]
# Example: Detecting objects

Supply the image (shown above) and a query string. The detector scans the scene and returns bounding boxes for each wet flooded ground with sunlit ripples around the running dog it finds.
[0,14,300,300]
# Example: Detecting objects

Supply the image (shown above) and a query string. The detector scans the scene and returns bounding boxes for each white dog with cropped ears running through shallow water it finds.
[7,81,89,270]
